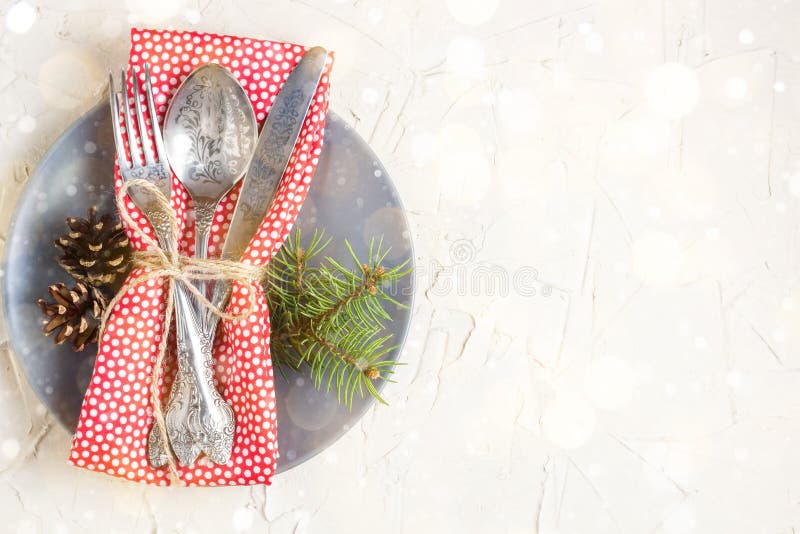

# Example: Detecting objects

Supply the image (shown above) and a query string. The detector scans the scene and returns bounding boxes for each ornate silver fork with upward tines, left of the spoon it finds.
[109,65,235,467]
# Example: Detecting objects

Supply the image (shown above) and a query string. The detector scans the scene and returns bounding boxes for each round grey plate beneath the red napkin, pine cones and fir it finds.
[3,103,413,472]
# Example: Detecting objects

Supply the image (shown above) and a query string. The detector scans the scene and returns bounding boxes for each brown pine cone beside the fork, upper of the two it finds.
[55,206,130,286]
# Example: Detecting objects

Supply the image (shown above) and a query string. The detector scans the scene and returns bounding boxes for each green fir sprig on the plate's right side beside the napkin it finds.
[265,230,411,407]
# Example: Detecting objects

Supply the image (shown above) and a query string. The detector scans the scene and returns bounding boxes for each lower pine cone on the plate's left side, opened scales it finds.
[38,281,107,351]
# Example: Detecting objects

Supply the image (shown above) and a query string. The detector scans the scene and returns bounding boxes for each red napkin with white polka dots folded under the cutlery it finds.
[69,29,333,486]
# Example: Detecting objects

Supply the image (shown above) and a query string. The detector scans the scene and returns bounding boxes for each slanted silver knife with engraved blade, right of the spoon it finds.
[207,46,328,318]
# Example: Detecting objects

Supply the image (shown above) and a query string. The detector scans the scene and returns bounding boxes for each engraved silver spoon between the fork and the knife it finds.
[151,64,258,465]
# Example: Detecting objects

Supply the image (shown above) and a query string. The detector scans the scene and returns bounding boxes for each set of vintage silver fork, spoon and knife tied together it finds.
[109,47,327,467]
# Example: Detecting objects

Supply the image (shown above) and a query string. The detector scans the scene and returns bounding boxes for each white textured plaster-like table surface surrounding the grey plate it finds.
[0,0,800,534]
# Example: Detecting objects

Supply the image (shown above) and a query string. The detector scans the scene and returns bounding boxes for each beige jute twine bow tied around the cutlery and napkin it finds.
[98,179,266,483]
